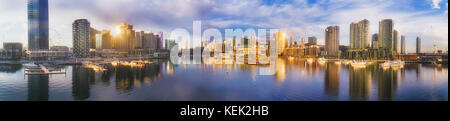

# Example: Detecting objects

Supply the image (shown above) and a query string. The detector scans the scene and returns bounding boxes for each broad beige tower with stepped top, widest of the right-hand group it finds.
[350,19,370,49]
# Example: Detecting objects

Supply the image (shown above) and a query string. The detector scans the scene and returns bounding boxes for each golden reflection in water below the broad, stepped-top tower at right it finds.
[349,67,370,101]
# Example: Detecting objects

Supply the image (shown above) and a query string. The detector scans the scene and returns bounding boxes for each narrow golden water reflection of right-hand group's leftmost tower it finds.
[324,63,341,97]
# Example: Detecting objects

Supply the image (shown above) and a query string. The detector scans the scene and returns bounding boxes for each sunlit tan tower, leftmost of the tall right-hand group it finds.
[325,26,339,57]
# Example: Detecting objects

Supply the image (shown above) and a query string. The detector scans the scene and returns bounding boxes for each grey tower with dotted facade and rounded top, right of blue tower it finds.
[72,19,91,57]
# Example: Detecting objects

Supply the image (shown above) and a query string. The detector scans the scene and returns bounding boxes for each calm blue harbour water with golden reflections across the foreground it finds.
[0,59,448,101]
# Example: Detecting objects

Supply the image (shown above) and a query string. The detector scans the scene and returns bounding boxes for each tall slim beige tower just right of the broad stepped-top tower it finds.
[378,19,394,51]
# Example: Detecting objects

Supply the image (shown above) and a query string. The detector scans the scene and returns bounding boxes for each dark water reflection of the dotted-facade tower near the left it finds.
[72,66,95,100]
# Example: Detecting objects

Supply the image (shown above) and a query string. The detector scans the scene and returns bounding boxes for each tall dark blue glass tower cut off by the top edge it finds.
[27,0,49,51]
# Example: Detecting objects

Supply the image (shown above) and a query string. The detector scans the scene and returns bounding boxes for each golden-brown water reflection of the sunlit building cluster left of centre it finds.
[115,63,162,91]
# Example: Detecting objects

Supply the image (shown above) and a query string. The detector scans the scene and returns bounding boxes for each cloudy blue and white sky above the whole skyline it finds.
[0,0,448,53]
